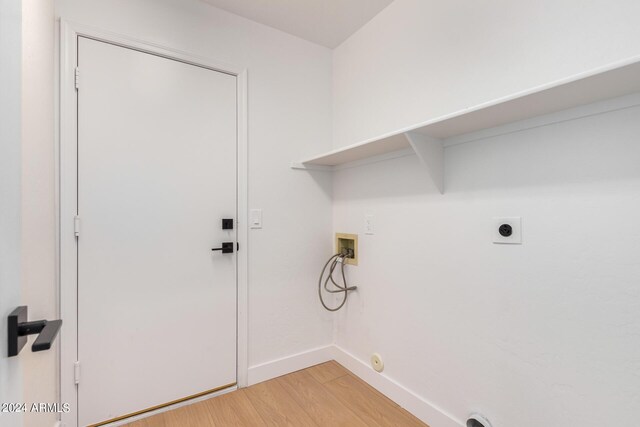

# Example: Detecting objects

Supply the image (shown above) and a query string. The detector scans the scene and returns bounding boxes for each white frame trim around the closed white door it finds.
[56,20,248,427]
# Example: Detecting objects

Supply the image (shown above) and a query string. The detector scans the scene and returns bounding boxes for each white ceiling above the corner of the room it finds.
[204,0,393,48]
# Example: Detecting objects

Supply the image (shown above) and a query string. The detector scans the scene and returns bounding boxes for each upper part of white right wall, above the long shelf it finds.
[332,0,640,149]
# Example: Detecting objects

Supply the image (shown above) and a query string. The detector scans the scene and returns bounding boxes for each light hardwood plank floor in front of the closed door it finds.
[122,361,428,427]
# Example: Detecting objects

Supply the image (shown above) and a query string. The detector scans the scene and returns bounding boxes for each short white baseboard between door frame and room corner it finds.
[248,345,333,385]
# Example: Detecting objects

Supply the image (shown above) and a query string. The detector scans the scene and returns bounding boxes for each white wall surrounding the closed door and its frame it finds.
[16,0,333,421]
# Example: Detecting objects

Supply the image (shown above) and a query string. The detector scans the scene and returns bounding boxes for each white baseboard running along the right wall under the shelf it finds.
[332,345,464,427]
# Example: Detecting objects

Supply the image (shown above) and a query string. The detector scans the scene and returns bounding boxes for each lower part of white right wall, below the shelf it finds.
[334,102,640,427]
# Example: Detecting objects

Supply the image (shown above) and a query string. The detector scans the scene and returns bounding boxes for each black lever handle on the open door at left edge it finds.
[7,305,62,357]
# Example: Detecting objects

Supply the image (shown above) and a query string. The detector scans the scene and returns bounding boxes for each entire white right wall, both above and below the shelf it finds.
[332,0,640,427]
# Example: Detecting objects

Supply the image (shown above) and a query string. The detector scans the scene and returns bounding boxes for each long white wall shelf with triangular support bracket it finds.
[291,58,640,193]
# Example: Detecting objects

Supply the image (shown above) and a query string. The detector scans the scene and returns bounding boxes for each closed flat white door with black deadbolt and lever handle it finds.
[78,37,237,426]
